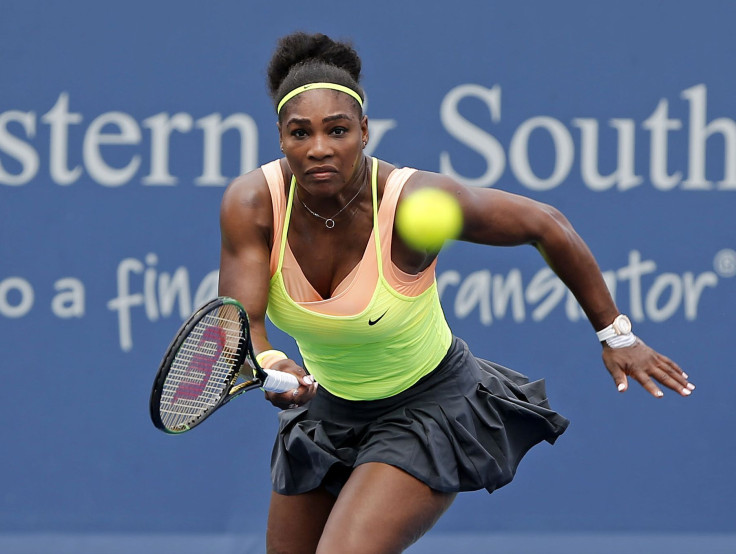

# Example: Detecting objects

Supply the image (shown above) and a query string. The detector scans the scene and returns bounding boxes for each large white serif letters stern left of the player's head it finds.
[0,92,264,187]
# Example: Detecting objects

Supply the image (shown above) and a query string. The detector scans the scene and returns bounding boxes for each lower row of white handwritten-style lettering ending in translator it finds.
[0,248,736,351]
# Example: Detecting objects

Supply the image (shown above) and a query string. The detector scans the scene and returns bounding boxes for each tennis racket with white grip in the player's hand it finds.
[150,296,299,434]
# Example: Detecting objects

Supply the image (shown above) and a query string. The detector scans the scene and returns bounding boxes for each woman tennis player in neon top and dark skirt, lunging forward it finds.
[219,33,694,554]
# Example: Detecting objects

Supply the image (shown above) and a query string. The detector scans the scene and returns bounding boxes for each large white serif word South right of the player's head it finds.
[439,84,736,191]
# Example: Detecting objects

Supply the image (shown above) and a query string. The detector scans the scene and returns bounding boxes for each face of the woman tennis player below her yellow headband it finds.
[279,89,368,197]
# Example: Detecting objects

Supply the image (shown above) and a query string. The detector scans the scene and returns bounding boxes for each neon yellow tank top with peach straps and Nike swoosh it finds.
[263,158,452,400]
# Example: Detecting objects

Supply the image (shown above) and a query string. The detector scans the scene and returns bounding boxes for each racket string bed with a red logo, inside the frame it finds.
[159,304,243,430]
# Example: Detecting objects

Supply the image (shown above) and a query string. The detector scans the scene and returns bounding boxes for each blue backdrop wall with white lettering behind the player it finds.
[0,0,736,552]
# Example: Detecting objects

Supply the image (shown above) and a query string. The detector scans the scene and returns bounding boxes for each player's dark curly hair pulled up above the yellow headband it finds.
[268,32,365,117]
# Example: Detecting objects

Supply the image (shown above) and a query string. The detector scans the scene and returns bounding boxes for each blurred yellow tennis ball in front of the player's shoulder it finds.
[396,188,463,252]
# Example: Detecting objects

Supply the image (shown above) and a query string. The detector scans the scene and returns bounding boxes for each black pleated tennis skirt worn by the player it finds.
[271,338,569,495]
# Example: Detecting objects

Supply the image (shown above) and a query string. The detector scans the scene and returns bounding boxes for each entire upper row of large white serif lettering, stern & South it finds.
[0,83,736,192]
